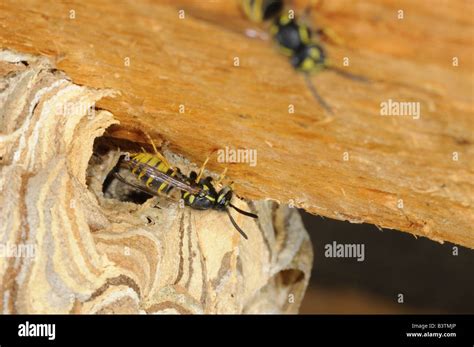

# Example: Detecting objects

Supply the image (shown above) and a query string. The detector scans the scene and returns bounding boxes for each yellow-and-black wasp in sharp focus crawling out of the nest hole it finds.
[114,138,258,239]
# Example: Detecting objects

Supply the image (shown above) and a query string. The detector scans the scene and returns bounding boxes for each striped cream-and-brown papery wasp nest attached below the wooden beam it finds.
[0,51,312,313]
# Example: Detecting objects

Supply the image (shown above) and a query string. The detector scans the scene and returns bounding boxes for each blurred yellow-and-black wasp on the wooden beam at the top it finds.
[242,0,367,113]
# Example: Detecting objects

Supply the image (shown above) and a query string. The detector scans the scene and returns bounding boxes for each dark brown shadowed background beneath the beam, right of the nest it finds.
[300,211,474,313]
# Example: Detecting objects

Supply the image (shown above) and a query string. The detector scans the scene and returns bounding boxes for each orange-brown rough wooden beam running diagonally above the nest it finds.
[0,0,474,248]
